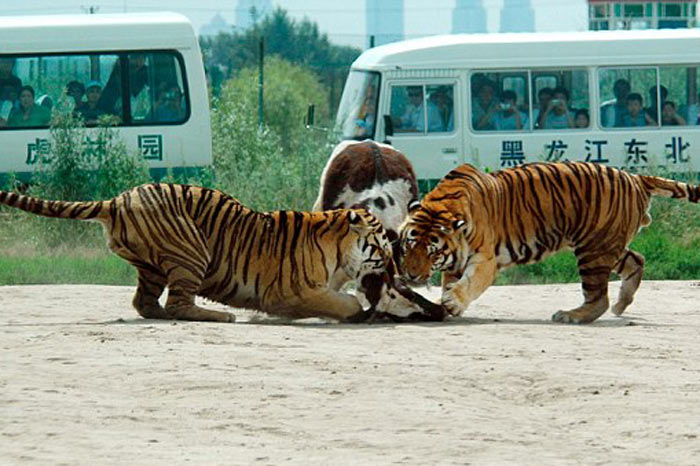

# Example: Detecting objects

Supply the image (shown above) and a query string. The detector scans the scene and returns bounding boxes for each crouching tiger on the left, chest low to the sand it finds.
[0,183,432,322]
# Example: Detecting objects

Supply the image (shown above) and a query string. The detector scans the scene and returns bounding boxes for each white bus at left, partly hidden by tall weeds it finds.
[0,13,212,183]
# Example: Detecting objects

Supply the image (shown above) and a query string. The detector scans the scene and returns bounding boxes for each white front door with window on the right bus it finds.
[383,79,463,180]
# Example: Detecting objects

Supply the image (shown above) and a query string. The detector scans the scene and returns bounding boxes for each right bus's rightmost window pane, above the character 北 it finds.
[659,66,700,126]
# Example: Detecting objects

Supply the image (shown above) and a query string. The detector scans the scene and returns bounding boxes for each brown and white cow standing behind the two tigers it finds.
[313,139,418,241]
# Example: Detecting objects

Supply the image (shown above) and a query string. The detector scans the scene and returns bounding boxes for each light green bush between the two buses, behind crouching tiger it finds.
[212,59,331,210]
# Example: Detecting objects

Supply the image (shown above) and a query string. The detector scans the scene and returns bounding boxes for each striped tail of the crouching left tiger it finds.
[0,191,111,221]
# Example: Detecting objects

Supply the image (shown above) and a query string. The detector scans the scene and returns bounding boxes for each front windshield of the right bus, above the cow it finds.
[336,71,379,139]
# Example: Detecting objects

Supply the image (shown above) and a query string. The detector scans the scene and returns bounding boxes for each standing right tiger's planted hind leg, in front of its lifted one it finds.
[552,253,618,324]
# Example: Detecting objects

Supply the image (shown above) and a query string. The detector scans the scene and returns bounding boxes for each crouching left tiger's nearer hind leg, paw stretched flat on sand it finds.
[163,261,236,322]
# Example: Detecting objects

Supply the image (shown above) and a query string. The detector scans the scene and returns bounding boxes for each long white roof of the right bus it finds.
[353,29,700,71]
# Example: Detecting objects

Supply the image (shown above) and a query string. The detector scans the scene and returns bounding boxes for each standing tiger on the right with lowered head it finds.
[400,162,700,324]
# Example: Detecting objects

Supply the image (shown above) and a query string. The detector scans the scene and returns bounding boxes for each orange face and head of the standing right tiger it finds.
[399,201,469,283]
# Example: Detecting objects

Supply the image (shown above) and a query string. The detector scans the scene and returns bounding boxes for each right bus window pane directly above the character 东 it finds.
[598,68,666,128]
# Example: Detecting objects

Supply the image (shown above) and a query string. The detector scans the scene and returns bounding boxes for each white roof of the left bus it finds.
[0,13,197,54]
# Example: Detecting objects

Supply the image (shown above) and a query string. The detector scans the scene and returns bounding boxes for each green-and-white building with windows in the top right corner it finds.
[588,0,697,31]
